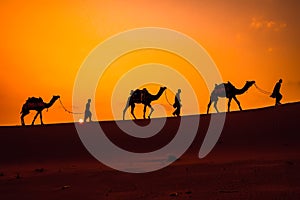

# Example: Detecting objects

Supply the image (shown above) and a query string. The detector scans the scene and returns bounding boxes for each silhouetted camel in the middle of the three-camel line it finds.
[123,87,167,120]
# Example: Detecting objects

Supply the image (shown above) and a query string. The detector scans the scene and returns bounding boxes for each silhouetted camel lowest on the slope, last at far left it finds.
[20,96,60,126]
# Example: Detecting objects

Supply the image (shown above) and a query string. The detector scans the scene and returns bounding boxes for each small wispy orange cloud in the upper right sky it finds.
[250,17,287,32]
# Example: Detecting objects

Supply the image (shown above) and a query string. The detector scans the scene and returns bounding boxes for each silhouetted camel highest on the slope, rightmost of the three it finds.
[207,81,255,114]
